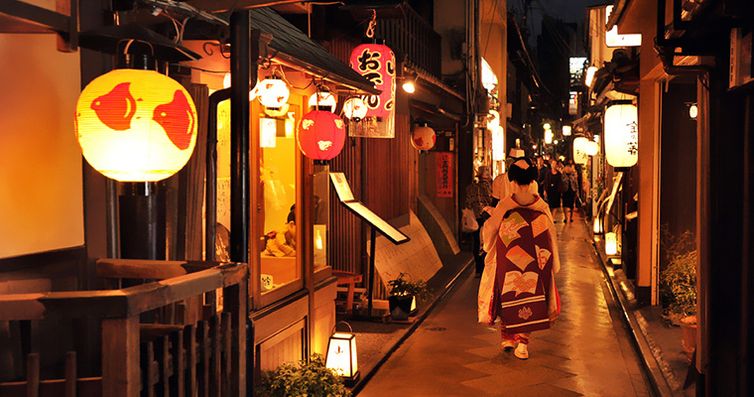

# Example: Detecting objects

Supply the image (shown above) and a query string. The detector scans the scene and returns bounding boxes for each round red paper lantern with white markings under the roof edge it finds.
[298,110,346,160]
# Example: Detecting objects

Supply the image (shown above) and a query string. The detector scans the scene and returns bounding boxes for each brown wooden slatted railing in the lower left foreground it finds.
[0,259,248,397]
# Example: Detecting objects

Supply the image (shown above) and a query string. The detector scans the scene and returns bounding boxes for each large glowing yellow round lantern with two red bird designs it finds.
[75,69,197,182]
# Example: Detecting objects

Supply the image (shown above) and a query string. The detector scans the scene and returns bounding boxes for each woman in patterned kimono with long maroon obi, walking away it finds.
[478,158,560,360]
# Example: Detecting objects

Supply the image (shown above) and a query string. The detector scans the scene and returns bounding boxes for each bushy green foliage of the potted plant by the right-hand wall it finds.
[660,250,697,317]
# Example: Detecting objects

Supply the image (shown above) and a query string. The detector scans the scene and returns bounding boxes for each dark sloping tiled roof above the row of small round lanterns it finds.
[250,7,379,93]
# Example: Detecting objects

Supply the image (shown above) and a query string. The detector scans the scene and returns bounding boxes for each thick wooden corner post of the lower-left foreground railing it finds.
[102,316,141,397]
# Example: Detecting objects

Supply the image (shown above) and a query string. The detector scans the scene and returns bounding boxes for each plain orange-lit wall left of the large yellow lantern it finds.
[0,34,84,260]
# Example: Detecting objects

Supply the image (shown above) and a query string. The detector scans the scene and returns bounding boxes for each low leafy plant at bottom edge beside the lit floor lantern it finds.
[256,354,351,397]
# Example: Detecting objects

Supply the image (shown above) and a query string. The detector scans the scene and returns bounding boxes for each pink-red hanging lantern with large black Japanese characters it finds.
[351,43,395,118]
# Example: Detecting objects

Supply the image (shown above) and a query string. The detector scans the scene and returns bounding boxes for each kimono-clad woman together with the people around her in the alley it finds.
[464,149,579,360]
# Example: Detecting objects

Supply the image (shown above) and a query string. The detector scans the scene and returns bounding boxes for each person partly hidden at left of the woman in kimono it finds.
[465,165,492,277]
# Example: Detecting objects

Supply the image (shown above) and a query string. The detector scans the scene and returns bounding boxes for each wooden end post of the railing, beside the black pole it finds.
[223,278,248,396]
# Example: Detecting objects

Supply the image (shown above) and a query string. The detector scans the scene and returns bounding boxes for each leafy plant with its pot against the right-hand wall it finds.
[660,250,697,357]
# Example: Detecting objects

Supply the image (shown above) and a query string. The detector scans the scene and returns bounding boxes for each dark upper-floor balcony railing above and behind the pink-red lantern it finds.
[376,4,442,79]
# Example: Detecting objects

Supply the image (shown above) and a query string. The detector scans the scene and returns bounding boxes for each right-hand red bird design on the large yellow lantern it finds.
[152,90,194,150]
